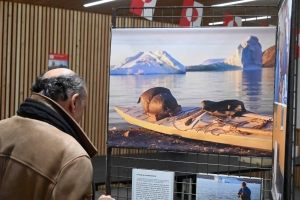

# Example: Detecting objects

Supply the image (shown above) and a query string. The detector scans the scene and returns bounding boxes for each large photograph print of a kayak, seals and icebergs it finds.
[108,27,275,154]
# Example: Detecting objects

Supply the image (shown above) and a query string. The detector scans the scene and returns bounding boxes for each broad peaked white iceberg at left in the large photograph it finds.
[110,50,186,75]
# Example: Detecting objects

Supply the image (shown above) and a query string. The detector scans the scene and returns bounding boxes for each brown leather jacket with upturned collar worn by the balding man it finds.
[0,94,97,200]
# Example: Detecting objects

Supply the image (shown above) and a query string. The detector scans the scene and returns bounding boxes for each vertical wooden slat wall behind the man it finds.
[0,1,172,155]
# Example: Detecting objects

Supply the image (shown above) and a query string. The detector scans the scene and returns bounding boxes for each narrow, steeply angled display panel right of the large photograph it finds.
[272,0,292,200]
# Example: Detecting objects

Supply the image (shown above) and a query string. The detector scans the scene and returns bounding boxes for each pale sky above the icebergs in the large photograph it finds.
[110,27,276,65]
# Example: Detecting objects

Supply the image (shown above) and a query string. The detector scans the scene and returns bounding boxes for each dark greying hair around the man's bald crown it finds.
[31,74,87,103]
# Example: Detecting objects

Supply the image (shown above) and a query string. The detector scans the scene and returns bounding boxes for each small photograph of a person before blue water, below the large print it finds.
[196,174,261,200]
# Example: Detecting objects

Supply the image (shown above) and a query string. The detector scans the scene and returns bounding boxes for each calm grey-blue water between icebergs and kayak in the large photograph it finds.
[109,68,274,128]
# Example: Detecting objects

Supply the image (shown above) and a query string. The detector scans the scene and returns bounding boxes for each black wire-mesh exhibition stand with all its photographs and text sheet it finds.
[104,0,300,199]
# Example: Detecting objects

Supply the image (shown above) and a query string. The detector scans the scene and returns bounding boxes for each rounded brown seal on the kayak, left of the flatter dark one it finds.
[137,87,181,120]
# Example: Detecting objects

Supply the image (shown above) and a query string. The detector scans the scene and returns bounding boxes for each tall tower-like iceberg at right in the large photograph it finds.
[223,36,262,69]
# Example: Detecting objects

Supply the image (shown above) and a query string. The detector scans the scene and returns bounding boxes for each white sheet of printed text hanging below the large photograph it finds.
[132,169,174,200]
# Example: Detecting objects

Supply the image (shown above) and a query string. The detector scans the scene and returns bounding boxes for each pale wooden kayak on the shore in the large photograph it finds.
[114,106,273,150]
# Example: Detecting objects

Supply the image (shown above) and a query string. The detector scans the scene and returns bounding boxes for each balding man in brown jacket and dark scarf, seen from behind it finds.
[0,68,113,200]
